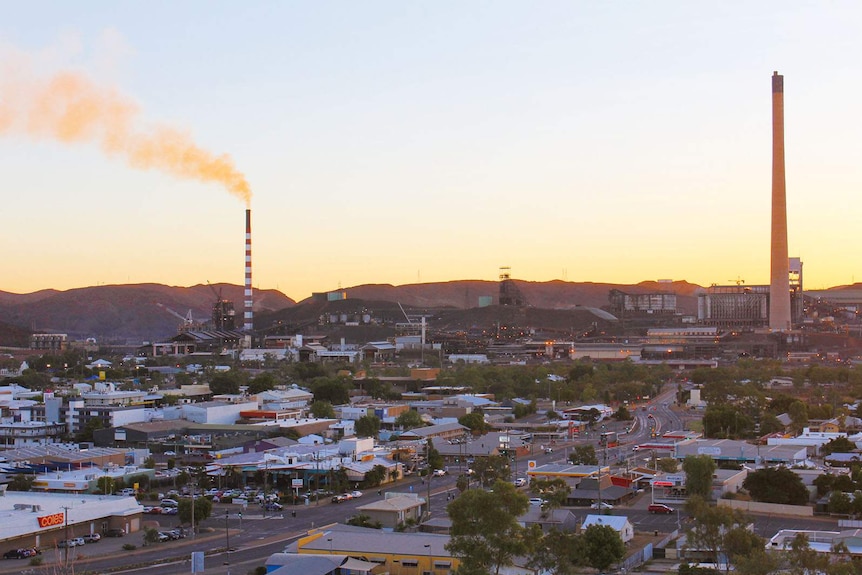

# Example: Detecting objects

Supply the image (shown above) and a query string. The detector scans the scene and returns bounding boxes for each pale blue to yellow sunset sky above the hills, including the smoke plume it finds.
[0,0,862,300]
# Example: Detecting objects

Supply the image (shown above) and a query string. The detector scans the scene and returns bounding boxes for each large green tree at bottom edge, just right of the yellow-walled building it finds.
[446,481,532,575]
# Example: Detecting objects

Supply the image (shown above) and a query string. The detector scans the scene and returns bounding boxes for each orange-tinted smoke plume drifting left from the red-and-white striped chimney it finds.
[0,61,251,205]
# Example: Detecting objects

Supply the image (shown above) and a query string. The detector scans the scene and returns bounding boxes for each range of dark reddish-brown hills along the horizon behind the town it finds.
[5,280,862,345]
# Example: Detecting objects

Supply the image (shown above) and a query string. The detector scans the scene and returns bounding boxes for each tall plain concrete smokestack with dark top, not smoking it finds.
[769,72,791,331]
